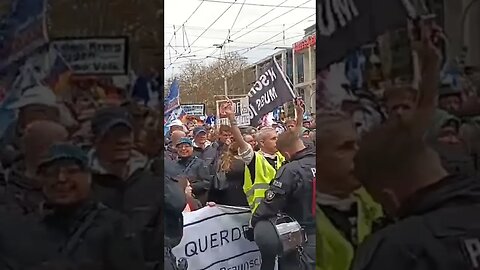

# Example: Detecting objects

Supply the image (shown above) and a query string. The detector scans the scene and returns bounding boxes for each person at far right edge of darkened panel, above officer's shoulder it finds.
[427,110,476,176]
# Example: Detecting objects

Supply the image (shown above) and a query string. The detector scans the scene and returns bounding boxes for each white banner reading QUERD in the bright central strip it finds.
[172,205,274,270]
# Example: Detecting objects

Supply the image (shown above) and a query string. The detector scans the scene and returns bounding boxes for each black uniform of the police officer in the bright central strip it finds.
[251,147,316,270]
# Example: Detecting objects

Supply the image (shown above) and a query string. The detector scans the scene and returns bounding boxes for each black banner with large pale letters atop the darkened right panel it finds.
[316,0,410,73]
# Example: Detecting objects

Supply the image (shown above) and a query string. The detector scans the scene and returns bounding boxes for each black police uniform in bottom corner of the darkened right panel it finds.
[352,176,480,270]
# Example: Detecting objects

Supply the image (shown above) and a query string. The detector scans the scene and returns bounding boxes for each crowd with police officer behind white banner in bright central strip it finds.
[164,100,315,269]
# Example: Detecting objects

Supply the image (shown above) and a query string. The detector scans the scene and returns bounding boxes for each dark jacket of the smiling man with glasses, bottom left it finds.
[0,202,144,270]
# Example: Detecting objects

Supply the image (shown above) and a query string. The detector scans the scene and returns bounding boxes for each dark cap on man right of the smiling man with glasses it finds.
[91,107,133,138]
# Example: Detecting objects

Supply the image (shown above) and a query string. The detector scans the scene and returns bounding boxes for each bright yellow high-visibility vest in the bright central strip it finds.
[243,152,285,213]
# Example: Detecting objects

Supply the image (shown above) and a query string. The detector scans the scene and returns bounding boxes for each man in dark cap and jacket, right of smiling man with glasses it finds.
[90,107,165,267]
